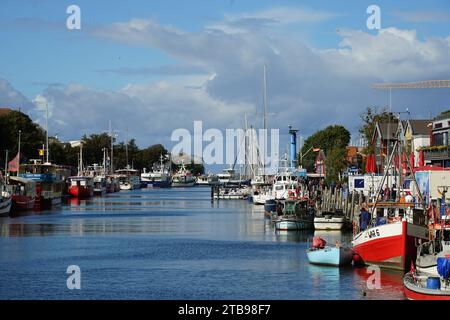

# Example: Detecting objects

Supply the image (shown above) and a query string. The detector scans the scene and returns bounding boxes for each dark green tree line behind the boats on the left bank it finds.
[0,110,204,174]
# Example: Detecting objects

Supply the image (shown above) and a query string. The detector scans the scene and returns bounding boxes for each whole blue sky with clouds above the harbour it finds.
[0,0,450,170]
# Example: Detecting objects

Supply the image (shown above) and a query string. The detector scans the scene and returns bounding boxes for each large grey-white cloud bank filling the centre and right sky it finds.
[0,9,450,151]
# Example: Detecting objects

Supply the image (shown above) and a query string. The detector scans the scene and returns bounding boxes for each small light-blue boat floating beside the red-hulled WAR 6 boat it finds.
[306,237,353,267]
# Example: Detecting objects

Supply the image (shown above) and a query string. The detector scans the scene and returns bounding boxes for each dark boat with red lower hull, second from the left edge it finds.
[8,176,36,211]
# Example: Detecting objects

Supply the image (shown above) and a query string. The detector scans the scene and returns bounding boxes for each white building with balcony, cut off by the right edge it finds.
[420,110,450,168]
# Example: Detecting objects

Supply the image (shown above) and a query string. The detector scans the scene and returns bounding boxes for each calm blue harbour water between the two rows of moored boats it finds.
[0,187,404,299]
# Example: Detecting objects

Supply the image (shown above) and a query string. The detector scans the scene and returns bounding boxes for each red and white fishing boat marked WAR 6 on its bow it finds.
[352,131,429,271]
